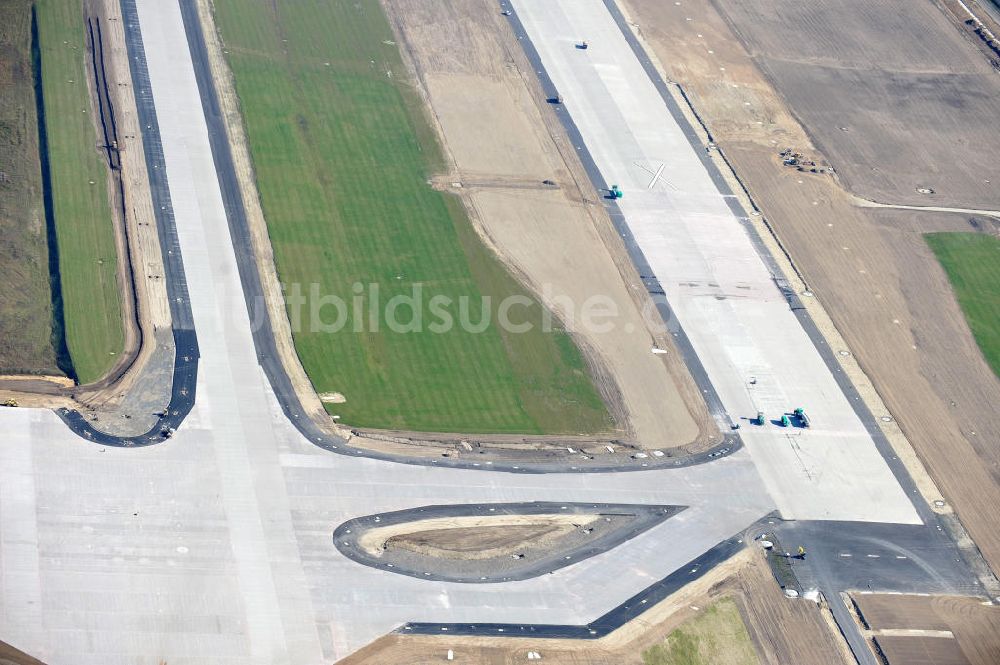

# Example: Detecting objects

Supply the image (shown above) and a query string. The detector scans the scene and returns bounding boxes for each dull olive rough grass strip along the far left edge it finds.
[0,0,59,374]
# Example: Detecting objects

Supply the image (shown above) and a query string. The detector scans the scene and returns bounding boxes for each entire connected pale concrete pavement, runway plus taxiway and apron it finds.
[0,0,976,665]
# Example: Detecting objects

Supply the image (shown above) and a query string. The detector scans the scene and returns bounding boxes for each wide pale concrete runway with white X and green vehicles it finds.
[511,0,919,523]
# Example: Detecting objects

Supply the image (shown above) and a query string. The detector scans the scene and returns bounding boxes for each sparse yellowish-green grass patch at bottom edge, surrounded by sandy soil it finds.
[642,598,760,665]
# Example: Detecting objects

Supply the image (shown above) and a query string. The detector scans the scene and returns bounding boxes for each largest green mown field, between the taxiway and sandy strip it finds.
[215,0,610,433]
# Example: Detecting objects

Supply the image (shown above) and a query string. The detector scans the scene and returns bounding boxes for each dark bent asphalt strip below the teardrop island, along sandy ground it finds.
[393,536,744,640]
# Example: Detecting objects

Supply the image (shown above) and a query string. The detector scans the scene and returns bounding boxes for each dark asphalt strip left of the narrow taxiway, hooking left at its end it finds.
[56,0,200,447]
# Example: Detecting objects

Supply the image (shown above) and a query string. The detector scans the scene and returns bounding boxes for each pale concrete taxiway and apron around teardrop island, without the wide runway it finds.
[0,0,774,665]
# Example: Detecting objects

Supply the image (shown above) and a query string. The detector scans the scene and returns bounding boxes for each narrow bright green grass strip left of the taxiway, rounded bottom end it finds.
[36,0,125,383]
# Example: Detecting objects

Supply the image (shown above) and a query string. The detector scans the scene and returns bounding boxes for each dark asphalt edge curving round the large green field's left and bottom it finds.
[166,0,742,473]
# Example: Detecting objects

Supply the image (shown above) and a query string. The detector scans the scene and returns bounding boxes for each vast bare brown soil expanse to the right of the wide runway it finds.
[623,0,1000,568]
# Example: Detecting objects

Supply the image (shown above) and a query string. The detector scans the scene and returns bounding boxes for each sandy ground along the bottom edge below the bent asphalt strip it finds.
[340,549,854,665]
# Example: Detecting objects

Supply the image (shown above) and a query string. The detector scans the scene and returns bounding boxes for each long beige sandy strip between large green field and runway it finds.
[384,0,717,448]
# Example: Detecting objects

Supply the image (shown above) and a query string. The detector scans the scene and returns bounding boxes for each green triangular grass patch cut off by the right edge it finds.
[925,233,1000,376]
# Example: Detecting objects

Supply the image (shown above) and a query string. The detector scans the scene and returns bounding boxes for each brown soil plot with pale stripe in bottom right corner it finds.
[851,594,1000,665]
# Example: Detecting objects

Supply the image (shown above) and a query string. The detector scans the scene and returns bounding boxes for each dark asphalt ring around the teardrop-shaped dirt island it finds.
[333,501,687,584]
